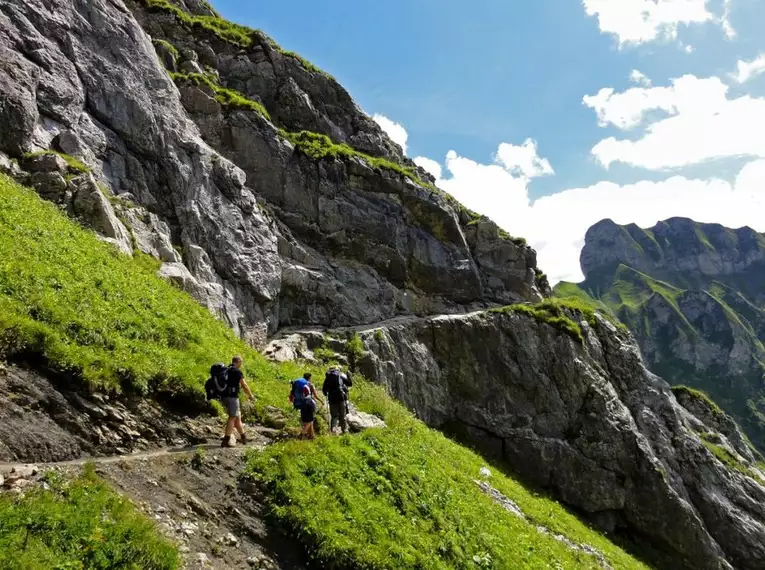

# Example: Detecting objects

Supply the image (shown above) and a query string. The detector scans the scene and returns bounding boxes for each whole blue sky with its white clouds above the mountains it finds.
[214,0,765,279]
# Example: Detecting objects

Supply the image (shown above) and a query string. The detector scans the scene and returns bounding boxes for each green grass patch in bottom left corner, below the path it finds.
[0,469,179,570]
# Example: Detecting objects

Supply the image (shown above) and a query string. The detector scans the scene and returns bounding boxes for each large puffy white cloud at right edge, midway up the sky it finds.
[584,75,765,170]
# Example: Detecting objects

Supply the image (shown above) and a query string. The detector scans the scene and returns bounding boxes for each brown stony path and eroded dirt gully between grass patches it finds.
[0,426,303,570]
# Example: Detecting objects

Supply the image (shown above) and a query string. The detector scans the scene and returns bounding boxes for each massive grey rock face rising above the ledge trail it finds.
[0,0,546,342]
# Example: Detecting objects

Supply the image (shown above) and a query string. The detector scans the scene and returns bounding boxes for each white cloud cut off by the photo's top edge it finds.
[583,0,712,47]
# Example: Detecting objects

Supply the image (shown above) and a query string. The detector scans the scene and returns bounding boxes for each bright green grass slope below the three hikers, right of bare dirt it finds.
[247,382,644,570]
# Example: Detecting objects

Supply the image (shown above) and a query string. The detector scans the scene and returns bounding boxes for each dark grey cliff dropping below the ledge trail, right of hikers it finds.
[352,313,765,569]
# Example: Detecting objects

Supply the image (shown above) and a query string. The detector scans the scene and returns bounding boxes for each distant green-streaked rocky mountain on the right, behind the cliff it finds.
[557,218,765,451]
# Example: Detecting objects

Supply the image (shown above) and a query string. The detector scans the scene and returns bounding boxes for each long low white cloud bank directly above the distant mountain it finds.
[426,146,765,283]
